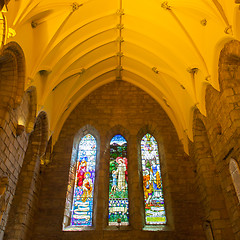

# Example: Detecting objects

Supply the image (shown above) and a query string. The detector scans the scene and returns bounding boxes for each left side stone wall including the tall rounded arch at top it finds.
[0,42,26,239]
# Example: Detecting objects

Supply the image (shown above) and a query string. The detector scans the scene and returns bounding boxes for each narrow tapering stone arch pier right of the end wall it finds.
[193,110,234,239]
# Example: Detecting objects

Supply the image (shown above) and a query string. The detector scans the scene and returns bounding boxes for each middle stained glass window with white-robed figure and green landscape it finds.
[108,135,129,226]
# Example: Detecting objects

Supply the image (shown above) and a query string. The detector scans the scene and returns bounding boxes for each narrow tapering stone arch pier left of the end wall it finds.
[4,112,48,240]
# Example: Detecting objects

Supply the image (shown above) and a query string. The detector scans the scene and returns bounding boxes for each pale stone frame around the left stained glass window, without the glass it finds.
[62,125,100,231]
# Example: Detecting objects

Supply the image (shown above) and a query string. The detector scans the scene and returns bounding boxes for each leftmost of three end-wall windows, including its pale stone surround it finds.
[63,126,99,231]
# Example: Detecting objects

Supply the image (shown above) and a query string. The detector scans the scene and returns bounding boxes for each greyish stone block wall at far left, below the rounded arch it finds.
[0,100,28,239]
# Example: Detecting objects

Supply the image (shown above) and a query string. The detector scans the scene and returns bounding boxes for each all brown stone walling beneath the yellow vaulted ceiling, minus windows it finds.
[0,41,240,240]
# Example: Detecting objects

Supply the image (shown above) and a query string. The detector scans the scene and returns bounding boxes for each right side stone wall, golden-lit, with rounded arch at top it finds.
[199,40,240,238]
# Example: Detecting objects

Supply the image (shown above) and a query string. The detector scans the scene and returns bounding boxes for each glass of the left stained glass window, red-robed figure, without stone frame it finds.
[71,134,97,226]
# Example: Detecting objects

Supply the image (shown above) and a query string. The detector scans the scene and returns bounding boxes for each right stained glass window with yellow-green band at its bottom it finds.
[141,133,166,225]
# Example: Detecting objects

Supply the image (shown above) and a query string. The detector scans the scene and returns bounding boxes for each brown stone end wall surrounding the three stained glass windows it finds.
[32,81,205,240]
